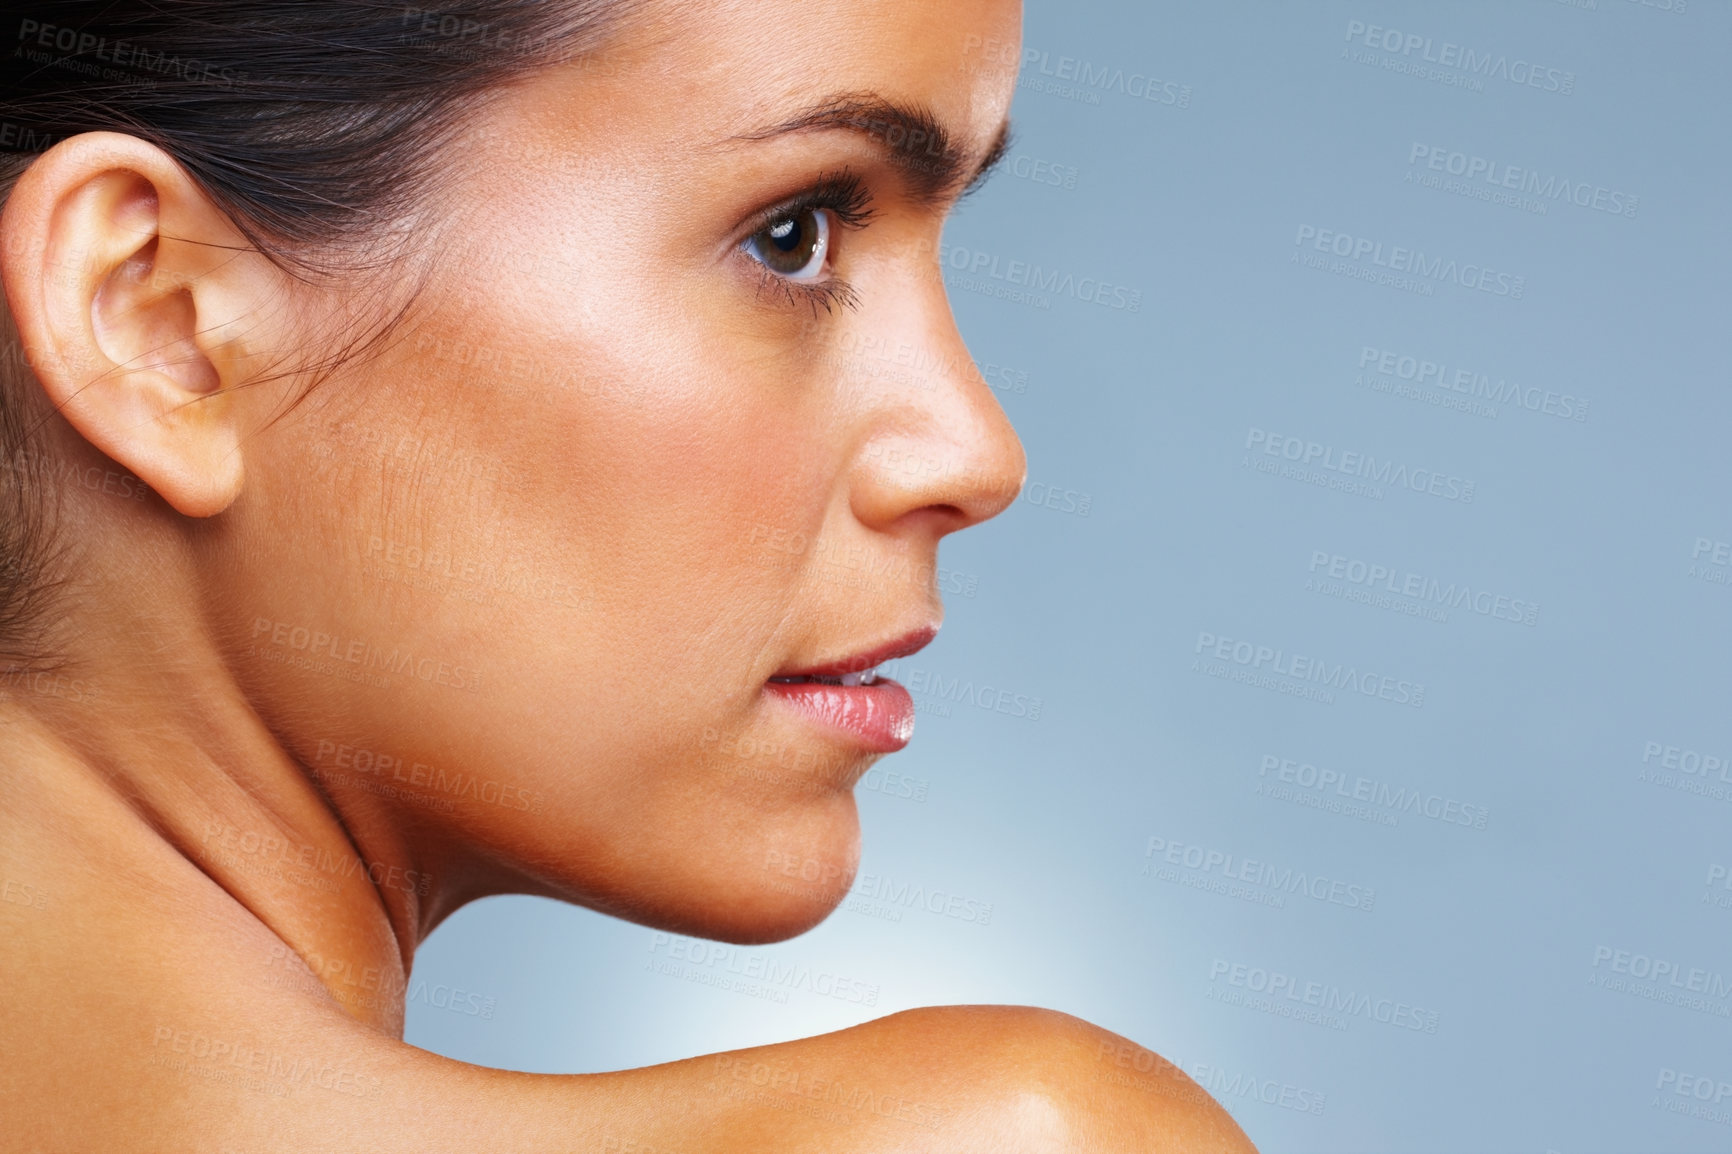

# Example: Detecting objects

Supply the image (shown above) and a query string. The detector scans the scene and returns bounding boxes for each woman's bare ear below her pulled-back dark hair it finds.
[0,132,274,516]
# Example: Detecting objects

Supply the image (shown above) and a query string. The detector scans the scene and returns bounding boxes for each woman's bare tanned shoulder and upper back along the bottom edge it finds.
[0,894,1254,1154]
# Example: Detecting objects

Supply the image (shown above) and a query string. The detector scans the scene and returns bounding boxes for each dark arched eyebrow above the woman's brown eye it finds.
[731,92,1010,204]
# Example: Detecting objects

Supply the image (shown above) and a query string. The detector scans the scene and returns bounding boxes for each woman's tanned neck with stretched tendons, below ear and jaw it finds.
[0,527,429,1038]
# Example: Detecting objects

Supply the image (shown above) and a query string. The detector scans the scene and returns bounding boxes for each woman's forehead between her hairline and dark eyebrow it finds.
[509,0,1022,171]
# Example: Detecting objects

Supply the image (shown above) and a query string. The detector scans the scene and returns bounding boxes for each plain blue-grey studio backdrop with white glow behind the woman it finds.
[398,0,1732,1154]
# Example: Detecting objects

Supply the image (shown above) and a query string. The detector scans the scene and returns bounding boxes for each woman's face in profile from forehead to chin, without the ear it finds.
[218,0,1024,939]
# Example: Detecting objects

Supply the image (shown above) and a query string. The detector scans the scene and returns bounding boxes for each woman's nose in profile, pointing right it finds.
[849,262,1027,537]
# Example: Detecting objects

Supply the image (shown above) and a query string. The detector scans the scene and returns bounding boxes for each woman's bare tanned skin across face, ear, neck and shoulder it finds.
[0,0,1252,1154]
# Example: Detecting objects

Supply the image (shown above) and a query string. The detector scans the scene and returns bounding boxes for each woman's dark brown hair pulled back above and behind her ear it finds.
[0,0,643,671]
